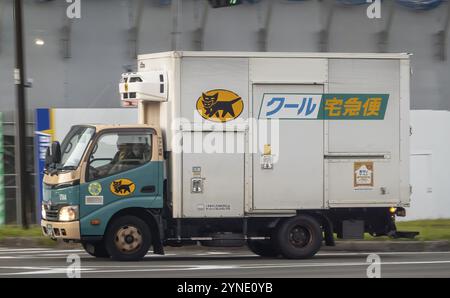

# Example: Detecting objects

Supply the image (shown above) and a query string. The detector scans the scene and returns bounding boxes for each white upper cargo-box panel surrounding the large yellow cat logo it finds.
[181,57,248,123]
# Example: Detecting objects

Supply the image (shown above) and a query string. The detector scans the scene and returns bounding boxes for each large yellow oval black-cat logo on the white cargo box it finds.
[197,89,244,123]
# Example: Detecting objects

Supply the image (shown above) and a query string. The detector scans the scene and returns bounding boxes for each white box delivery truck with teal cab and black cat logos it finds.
[42,52,415,260]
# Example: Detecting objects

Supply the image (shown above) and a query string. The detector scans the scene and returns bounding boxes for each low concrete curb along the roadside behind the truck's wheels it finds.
[0,237,450,252]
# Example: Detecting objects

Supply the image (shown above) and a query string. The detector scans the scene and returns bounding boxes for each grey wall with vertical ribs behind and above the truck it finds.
[0,0,450,121]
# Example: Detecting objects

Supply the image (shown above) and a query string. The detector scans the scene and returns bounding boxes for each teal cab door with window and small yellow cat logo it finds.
[80,129,163,235]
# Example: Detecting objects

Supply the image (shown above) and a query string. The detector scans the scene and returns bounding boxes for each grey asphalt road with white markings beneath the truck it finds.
[0,247,450,278]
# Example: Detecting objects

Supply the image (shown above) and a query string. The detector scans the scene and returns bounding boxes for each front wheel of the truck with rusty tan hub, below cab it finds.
[105,215,152,262]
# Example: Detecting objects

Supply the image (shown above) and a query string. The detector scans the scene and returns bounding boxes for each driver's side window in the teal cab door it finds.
[87,132,152,181]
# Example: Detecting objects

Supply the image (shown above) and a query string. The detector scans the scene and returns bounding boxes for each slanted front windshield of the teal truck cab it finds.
[61,126,95,170]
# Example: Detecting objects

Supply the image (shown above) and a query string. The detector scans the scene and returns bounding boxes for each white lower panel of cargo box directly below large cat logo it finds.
[183,132,245,218]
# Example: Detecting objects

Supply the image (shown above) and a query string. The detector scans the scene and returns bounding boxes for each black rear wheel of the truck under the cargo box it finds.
[274,215,323,259]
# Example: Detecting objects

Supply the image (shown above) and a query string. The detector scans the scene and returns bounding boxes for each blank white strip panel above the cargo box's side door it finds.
[250,58,328,84]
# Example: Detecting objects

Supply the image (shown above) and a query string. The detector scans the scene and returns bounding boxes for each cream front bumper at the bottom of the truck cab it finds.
[41,220,80,240]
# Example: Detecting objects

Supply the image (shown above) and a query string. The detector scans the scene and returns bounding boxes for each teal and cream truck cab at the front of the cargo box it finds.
[42,125,164,257]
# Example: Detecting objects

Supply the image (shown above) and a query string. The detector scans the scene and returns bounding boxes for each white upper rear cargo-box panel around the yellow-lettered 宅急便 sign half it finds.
[327,59,400,156]
